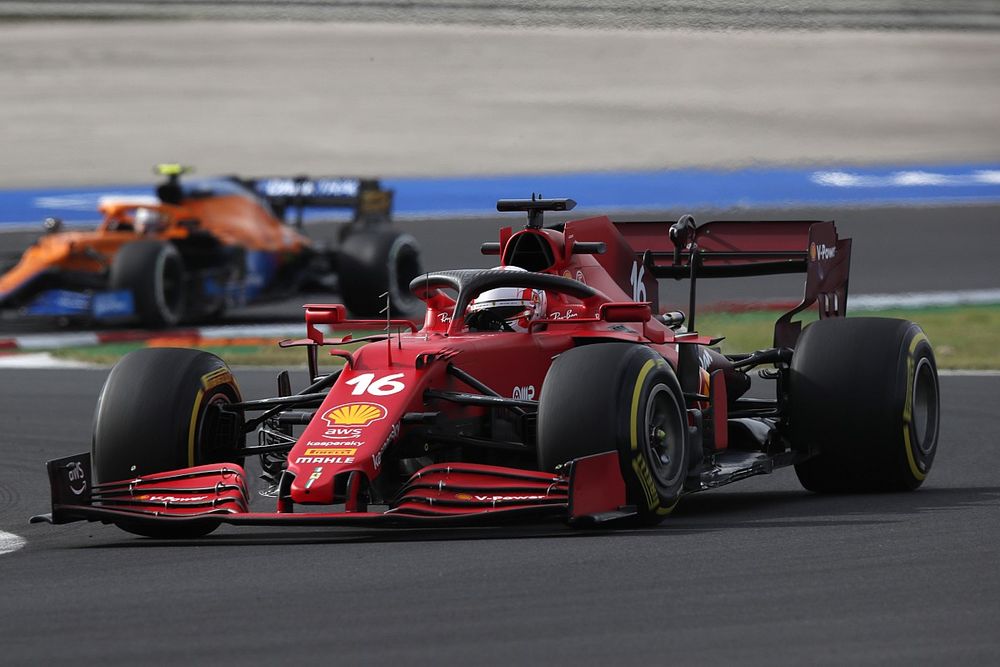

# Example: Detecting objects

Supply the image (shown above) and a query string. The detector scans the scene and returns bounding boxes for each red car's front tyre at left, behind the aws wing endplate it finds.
[91,348,244,537]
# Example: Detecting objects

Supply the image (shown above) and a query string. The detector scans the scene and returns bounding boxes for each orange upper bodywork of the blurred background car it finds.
[0,194,311,295]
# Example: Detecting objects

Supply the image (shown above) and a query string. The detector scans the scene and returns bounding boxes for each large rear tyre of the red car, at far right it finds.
[789,318,940,493]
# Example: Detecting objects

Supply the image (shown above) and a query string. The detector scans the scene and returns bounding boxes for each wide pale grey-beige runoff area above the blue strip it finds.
[0,20,1000,188]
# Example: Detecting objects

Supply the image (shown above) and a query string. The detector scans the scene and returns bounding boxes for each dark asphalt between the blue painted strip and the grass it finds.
[0,201,1000,333]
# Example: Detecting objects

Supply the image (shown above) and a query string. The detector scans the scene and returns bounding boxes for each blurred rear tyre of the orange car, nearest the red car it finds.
[337,227,423,317]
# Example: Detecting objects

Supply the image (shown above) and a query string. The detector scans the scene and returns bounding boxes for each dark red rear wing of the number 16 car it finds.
[615,215,851,347]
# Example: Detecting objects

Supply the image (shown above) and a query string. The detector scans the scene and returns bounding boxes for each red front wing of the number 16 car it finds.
[31,452,634,528]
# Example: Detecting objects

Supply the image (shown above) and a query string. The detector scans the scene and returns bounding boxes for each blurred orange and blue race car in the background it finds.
[0,165,422,327]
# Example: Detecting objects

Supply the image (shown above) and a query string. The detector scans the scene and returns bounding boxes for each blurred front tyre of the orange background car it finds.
[109,239,186,328]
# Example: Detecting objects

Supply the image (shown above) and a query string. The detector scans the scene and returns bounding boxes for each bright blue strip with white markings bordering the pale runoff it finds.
[0,163,1000,228]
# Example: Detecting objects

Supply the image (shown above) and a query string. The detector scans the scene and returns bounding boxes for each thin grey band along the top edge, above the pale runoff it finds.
[7,0,1000,30]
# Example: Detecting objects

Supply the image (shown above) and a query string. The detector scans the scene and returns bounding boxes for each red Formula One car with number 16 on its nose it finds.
[29,199,939,537]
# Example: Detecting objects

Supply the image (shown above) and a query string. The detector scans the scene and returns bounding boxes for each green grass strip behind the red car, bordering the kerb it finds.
[43,306,1000,369]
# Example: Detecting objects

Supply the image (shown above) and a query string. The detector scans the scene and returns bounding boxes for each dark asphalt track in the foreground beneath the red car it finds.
[0,369,1000,665]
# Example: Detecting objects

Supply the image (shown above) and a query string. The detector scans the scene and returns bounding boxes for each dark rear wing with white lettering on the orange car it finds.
[236,176,393,226]
